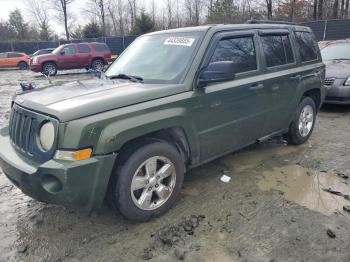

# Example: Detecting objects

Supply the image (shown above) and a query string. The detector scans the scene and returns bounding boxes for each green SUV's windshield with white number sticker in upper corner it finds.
[106,32,201,83]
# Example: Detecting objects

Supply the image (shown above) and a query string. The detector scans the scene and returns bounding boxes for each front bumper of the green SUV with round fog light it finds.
[0,128,116,212]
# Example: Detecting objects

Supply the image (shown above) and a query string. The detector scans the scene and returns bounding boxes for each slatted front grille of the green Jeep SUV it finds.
[9,107,37,155]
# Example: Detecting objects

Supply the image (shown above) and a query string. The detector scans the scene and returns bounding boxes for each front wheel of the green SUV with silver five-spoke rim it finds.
[109,141,185,222]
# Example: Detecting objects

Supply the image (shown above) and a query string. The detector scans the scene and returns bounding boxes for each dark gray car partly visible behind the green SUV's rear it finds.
[321,40,350,105]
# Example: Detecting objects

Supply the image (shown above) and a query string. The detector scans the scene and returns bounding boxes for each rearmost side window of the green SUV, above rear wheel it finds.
[295,32,317,62]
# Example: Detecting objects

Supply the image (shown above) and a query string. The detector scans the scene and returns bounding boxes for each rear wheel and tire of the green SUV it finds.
[286,97,317,145]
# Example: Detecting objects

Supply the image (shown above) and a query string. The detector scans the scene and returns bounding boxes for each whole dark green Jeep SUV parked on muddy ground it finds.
[0,24,325,221]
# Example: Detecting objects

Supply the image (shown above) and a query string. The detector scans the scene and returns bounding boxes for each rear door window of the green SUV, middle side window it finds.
[260,35,294,67]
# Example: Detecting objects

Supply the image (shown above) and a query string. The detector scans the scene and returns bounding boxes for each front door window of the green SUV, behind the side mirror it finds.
[210,36,258,73]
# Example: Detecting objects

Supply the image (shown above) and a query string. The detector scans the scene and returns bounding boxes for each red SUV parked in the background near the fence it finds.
[29,43,112,76]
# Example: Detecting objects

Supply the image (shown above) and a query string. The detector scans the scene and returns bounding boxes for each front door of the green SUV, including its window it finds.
[195,31,265,161]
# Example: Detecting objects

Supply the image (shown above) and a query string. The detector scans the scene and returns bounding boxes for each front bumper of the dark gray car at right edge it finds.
[324,79,350,105]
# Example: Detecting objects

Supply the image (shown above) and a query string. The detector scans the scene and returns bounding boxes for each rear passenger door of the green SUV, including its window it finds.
[259,29,300,136]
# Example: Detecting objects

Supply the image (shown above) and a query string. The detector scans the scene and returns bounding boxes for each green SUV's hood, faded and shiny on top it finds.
[14,79,184,122]
